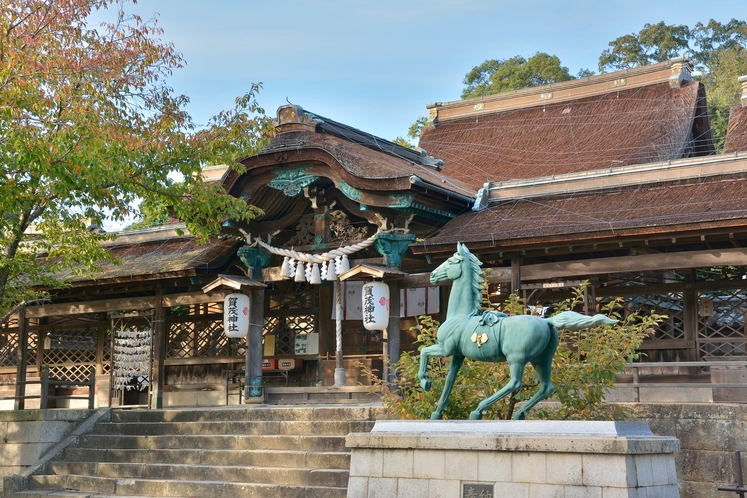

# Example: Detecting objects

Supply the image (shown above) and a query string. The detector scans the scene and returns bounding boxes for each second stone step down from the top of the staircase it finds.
[96,420,374,436]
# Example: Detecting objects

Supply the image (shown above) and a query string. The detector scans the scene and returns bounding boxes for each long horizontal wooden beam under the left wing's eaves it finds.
[26,291,229,318]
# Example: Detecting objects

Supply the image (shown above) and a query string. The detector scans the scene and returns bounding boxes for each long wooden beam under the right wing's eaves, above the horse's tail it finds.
[521,248,747,280]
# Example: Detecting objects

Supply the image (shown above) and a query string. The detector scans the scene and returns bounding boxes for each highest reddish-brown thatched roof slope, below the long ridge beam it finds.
[420,82,713,188]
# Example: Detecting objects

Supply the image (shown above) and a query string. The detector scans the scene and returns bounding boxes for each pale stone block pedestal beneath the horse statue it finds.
[346,420,679,498]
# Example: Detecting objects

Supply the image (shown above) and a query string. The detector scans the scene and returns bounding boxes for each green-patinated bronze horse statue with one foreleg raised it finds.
[418,243,617,420]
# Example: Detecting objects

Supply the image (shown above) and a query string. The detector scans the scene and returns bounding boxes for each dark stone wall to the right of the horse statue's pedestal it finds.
[630,403,747,498]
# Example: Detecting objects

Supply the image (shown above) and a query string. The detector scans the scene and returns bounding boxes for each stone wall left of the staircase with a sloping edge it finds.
[0,410,94,491]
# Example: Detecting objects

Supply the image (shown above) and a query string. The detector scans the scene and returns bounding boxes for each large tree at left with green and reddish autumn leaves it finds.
[0,0,271,320]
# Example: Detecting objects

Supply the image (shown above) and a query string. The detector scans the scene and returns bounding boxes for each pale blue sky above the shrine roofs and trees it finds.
[121,0,747,144]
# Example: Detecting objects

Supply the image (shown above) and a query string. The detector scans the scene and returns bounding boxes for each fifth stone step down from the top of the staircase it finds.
[50,461,348,487]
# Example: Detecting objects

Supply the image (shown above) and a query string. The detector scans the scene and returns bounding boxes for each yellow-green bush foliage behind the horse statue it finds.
[368,288,665,420]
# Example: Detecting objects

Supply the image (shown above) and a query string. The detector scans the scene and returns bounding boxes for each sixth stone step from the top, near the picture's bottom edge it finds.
[25,475,347,498]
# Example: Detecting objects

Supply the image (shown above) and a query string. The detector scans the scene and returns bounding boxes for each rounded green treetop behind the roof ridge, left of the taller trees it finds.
[462,52,575,99]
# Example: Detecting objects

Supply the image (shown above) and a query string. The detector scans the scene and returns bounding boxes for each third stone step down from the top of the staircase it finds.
[79,434,346,451]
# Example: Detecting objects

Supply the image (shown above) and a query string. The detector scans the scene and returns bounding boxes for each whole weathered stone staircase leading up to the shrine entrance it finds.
[5,405,376,498]
